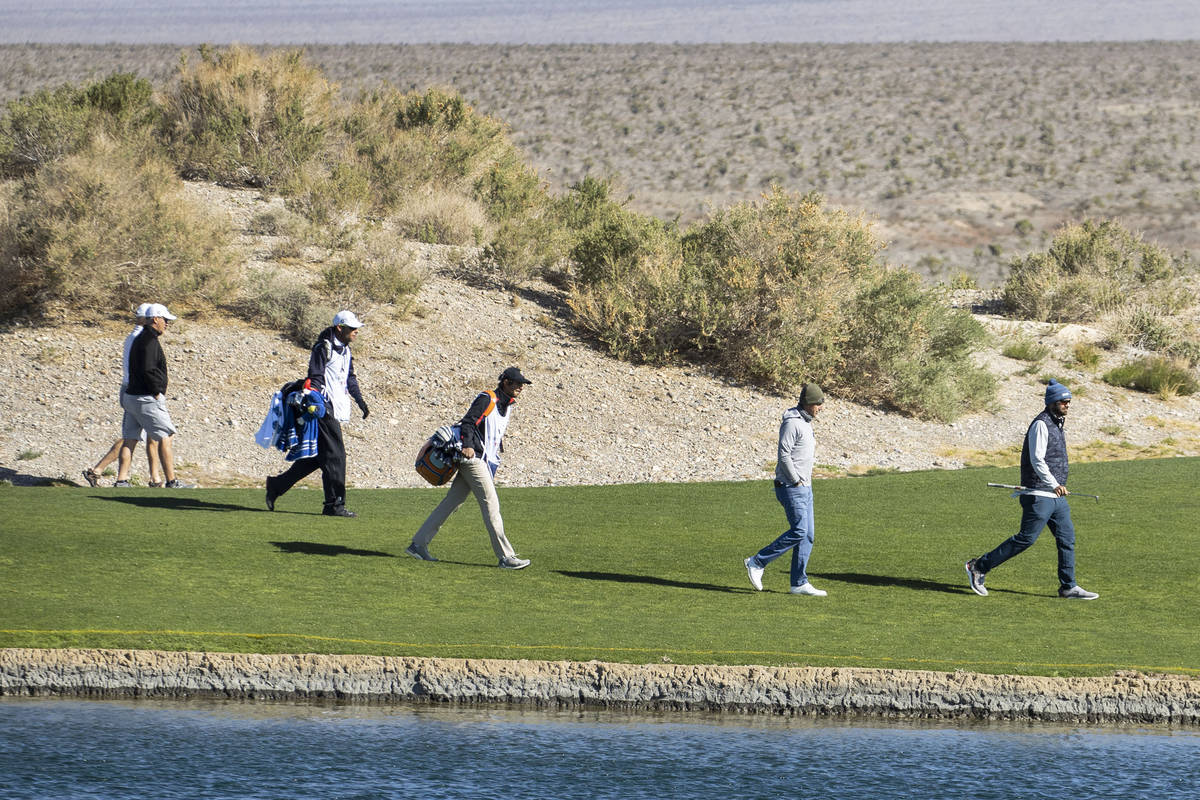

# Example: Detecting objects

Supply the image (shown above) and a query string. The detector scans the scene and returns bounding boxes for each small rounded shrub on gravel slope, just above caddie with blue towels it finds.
[317,231,425,311]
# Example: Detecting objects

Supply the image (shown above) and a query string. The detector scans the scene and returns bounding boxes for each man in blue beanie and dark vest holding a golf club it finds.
[966,379,1099,600]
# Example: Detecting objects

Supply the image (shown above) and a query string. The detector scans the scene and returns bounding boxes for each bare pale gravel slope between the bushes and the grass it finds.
[0,184,1200,491]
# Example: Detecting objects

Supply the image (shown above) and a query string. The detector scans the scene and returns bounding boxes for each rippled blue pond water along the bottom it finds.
[0,698,1200,800]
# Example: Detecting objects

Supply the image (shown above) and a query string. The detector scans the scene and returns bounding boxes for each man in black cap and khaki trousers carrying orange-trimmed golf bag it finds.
[404,367,533,570]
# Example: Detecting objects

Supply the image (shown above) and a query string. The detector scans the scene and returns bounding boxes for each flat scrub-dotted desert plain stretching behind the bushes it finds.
[0,42,1200,287]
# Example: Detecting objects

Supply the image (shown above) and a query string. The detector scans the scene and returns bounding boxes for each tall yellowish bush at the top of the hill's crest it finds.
[163,47,337,186]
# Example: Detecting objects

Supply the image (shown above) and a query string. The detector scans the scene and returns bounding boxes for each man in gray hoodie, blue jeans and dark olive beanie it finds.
[745,384,828,597]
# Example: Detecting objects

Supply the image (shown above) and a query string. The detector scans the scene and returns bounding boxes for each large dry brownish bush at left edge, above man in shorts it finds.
[0,137,238,312]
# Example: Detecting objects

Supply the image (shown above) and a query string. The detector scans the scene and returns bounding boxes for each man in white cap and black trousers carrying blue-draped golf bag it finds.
[266,311,371,517]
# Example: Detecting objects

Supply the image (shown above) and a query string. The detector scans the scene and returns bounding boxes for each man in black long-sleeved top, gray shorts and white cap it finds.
[121,302,194,489]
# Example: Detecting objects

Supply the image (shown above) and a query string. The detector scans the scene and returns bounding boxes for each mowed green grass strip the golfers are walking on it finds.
[0,458,1200,675]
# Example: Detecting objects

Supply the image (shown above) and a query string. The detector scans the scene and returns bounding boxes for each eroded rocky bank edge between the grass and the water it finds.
[0,649,1200,726]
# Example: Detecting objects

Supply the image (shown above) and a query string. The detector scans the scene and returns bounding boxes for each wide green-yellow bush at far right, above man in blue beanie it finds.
[1004,219,1195,323]
